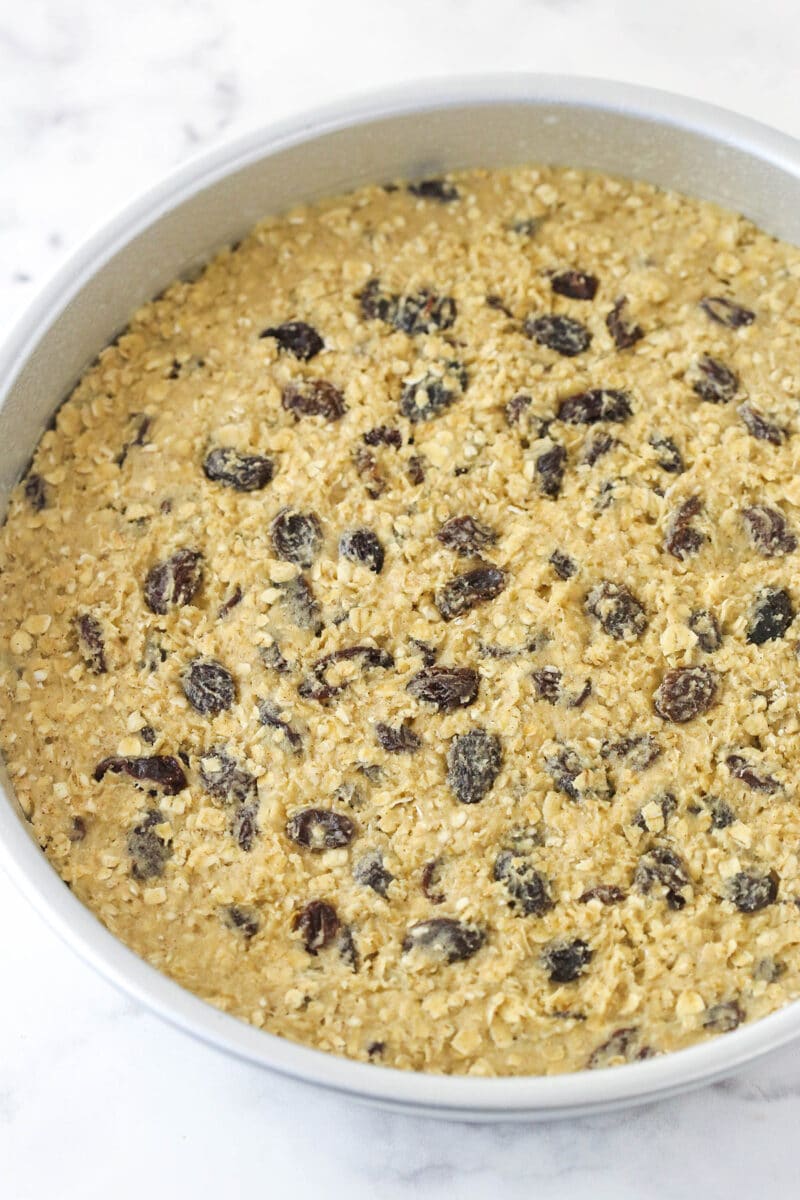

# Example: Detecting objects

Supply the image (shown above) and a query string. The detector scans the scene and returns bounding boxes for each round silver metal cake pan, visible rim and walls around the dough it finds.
[0,76,800,1121]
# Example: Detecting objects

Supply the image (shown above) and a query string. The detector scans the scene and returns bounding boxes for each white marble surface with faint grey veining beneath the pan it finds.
[0,0,800,1200]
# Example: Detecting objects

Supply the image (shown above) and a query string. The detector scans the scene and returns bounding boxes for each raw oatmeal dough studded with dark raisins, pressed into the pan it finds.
[0,168,800,1075]
